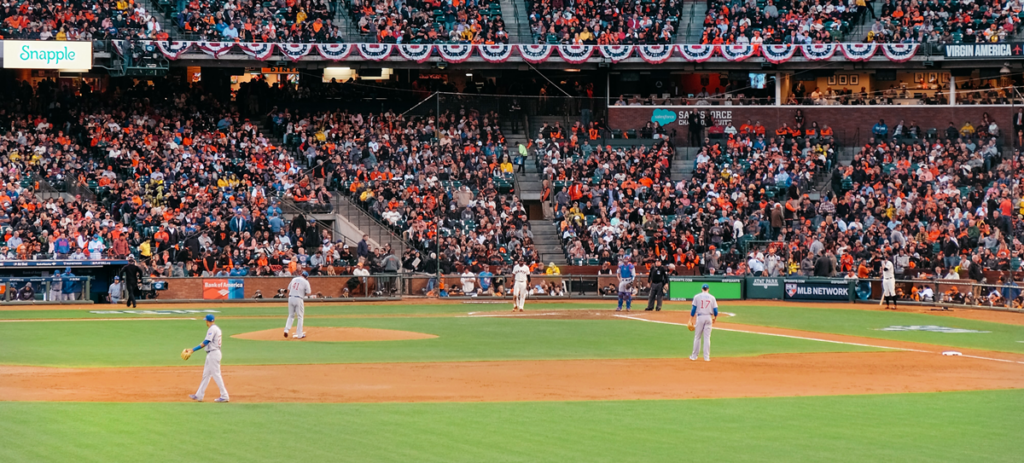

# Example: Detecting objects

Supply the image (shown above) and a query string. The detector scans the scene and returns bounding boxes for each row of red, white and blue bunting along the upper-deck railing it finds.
[99,40,919,65]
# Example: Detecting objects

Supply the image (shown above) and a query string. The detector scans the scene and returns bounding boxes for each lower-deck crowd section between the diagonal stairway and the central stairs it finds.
[262,102,538,282]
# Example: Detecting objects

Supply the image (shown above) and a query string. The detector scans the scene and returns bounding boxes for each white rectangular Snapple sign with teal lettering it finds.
[3,40,92,71]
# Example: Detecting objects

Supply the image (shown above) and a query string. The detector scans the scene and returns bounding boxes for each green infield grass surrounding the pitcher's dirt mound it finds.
[0,318,873,367]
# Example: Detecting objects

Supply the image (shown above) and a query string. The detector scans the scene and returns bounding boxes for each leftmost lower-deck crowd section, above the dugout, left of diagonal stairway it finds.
[0,75,380,277]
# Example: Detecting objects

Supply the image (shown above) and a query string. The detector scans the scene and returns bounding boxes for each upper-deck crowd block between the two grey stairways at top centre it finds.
[528,0,683,45]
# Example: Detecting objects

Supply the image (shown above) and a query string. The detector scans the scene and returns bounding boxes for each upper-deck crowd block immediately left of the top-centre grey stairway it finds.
[349,0,509,44]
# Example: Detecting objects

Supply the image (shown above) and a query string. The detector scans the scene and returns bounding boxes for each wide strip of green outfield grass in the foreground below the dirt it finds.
[0,390,1024,463]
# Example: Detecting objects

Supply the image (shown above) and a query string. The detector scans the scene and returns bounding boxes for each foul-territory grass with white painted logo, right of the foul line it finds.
[727,305,1024,353]
